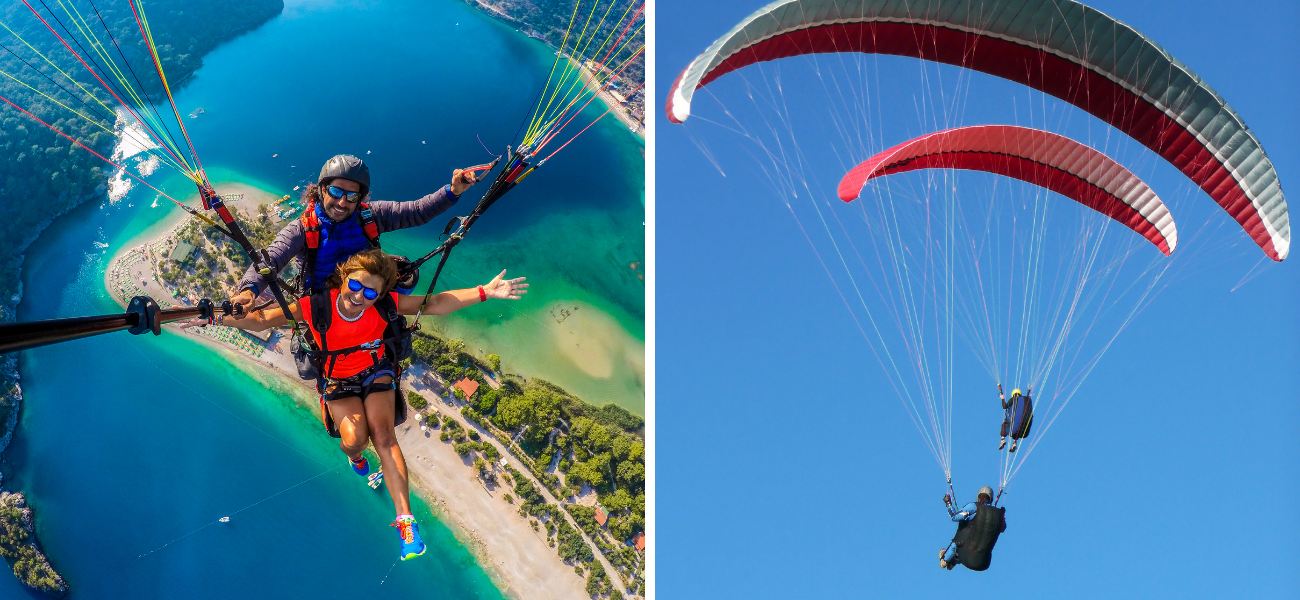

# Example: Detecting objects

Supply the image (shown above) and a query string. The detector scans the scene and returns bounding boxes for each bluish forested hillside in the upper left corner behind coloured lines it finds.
[0,0,285,305]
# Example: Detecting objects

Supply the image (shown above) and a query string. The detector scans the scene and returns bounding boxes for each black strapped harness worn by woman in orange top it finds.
[295,290,416,438]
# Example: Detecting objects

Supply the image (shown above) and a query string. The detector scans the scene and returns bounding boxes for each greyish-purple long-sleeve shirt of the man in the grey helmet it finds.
[238,186,459,296]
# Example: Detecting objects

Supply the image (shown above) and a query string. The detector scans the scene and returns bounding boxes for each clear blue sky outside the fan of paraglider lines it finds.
[655,0,1300,599]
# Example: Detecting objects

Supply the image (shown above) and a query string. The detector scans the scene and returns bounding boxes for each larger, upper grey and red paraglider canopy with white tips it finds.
[664,0,1291,261]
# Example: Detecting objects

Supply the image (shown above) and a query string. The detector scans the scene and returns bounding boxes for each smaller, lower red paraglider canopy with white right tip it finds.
[839,125,1178,255]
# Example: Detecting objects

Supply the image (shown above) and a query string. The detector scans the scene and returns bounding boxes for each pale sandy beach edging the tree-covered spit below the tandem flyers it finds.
[104,183,636,600]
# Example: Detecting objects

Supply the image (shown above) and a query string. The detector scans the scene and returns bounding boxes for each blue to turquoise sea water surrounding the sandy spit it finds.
[0,0,645,599]
